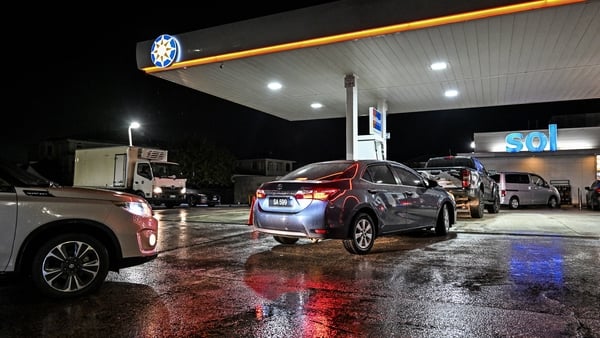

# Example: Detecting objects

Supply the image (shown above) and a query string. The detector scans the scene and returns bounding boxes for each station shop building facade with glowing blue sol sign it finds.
[461,124,600,206]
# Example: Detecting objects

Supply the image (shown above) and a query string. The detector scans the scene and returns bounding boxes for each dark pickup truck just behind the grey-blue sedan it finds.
[414,156,500,218]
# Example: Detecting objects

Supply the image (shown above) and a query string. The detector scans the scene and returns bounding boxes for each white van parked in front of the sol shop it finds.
[492,171,560,209]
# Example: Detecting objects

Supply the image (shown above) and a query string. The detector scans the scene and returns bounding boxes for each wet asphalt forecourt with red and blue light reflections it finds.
[0,206,600,337]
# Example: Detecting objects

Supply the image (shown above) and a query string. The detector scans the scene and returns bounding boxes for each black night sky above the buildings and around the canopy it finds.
[5,1,600,163]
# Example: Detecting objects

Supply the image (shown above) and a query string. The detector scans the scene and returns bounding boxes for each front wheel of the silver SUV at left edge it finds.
[31,233,109,298]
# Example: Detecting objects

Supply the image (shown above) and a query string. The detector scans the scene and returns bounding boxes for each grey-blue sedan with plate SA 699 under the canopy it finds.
[251,160,456,255]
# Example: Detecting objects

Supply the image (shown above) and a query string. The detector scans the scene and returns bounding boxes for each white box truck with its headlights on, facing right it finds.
[73,146,186,208]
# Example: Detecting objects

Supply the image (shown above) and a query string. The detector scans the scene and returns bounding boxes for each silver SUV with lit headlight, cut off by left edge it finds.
[0,163,158,298]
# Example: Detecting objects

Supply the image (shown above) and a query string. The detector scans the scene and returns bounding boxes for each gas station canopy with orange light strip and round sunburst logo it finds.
[136,0,600,121]
